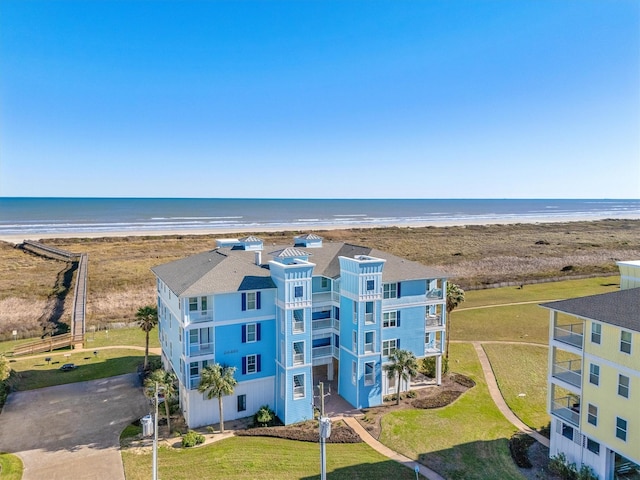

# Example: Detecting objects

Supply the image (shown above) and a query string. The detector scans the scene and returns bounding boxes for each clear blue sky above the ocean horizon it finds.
[0,0,640,198]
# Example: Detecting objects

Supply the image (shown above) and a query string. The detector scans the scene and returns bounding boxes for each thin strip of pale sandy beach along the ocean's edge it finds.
[0,215,640,245]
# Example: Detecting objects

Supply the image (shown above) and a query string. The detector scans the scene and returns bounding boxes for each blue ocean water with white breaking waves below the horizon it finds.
[0,198,640,236]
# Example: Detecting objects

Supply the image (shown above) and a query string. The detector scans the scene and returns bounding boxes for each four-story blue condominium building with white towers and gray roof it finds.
[152,234,447,428]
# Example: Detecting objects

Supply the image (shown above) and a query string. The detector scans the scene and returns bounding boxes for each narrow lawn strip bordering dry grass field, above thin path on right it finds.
[460,276,620,310]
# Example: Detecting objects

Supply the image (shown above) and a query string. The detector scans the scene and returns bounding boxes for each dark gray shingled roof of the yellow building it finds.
[540,288,640,332]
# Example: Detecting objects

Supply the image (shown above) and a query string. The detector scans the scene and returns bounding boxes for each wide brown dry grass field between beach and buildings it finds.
[0,220,640,340]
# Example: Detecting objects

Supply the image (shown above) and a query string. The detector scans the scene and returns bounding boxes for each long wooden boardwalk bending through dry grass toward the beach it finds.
[13,240,89,355]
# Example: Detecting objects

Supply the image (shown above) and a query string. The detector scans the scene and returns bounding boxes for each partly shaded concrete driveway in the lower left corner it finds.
[0,374,149,480]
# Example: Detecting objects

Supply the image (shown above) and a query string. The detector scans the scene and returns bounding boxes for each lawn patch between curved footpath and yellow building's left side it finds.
[483,343,549,429]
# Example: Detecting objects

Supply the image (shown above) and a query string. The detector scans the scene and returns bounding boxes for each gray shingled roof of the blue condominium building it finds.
[151,242,447,296]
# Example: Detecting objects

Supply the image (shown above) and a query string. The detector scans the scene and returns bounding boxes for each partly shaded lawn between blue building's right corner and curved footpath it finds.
[380,344,524,480]
